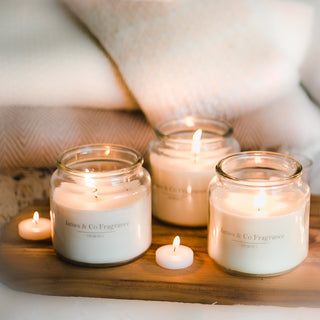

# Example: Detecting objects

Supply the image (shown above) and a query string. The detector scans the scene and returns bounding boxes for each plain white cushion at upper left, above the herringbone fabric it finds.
[0,0,136,110]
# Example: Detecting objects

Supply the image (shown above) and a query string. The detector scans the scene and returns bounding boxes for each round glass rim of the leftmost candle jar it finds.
[57,143,143,177]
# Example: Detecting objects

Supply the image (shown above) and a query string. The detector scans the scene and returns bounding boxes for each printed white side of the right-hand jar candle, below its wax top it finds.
[208,203,309,274]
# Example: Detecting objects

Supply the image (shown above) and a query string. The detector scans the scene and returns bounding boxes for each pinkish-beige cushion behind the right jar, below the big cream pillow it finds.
[232,85,320,152]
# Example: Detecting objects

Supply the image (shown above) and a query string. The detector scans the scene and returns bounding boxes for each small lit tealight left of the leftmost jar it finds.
[18,211,51,240]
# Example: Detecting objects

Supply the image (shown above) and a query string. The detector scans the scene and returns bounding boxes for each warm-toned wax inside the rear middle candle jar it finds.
[150,150,232,226]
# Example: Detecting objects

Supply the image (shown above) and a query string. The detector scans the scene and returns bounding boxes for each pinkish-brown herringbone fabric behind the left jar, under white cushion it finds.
[0,107,154,168]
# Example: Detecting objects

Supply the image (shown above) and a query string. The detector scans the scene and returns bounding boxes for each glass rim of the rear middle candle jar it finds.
[154,115,233,143]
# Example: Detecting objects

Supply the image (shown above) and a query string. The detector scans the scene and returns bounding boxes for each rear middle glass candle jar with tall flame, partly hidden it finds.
[149,116,239,227]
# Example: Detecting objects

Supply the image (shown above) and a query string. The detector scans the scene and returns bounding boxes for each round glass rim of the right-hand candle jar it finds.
[216,151,303,187]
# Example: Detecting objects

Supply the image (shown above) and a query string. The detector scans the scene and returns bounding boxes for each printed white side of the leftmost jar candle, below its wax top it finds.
[52,195,151,264]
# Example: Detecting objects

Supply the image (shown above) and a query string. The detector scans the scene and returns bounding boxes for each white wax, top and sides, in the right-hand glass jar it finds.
[208,191,310,275]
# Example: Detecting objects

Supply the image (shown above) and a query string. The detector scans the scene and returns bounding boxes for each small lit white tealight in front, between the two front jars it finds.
[156,236,193,269]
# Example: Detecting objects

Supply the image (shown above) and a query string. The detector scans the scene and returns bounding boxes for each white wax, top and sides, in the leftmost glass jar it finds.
[52,183,151,264]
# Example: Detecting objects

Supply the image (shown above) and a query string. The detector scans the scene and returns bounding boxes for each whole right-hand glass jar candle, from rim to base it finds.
[208,151,310,276]
